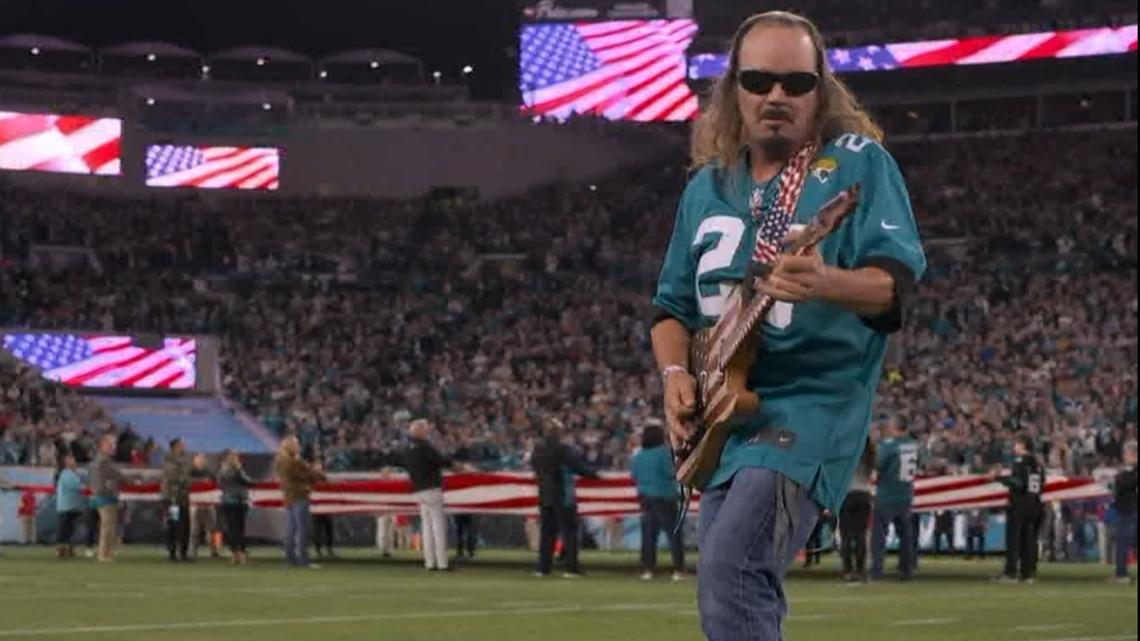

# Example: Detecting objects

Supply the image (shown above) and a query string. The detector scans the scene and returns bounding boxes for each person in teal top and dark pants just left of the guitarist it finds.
[629,421,685,581]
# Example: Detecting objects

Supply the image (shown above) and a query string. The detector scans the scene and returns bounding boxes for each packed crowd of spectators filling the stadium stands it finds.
[0,126,1137,473]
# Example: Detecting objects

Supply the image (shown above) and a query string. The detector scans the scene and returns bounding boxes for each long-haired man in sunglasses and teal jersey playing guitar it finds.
[652,13,926,641]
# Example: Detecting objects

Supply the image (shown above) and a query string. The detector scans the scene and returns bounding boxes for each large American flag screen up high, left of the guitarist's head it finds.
[519,19,699,121]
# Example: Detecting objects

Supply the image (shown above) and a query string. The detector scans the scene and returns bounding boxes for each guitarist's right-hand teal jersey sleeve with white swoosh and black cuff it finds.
[842,145,927,333]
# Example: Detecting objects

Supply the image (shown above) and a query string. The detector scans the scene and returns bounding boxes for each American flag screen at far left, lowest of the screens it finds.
[3,334,197,389]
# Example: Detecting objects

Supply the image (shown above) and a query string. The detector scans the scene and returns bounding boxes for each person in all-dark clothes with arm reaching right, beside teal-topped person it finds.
[530,417,599,578]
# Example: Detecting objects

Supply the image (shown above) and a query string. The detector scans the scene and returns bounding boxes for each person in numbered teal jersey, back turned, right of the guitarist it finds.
[871,417,919,581]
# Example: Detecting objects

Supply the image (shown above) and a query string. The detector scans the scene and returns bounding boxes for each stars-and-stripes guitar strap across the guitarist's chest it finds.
[750,143,816,267]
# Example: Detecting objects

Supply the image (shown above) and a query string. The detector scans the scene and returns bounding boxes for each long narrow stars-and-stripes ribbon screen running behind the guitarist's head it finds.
[689,25,1137,80]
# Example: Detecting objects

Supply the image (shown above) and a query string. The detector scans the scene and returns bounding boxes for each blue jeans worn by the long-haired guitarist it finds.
[697,468,820,641]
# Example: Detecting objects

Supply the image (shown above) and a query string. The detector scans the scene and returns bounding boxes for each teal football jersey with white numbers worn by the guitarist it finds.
[653,133,926,512]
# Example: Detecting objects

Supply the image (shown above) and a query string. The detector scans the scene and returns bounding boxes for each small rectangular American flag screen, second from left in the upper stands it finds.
[146,145,280,189]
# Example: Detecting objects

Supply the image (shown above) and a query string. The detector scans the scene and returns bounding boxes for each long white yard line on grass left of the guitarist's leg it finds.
[0,605,688,638]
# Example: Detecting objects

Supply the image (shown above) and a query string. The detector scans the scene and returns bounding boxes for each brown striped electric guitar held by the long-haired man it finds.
[674,185,860,489]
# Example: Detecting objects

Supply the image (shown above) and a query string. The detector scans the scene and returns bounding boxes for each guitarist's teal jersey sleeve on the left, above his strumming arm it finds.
[653,180,700,331]
